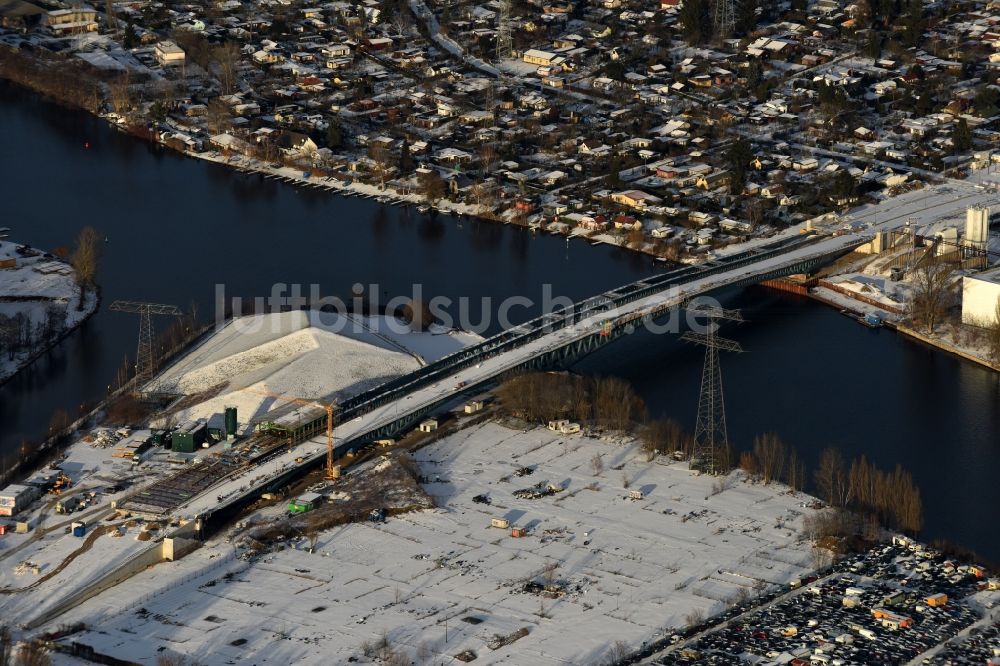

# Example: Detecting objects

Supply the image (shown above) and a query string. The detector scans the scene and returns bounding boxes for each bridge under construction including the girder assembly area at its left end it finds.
[113,226,870,537]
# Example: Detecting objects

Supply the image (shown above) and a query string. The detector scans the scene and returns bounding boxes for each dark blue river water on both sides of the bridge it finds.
[0,83,1000,561]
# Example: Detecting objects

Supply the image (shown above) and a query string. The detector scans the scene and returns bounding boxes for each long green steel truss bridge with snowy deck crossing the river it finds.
[191,234,870,535]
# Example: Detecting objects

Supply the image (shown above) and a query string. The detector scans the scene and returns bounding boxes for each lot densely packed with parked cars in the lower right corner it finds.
[653,542,998,665]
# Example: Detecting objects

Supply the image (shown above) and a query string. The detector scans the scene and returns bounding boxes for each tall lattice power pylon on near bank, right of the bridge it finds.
[681,305,743,474]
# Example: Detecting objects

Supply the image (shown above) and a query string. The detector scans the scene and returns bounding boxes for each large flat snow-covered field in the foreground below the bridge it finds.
[45,423,811,666]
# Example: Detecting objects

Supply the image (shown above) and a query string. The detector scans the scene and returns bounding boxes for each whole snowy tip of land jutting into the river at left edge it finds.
[0,241,101,385]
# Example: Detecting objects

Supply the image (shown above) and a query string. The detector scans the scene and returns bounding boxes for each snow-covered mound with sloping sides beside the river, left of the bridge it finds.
[149,311,479,428]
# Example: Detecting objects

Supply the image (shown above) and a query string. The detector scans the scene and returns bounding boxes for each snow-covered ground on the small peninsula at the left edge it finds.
[0,240,97,382]
